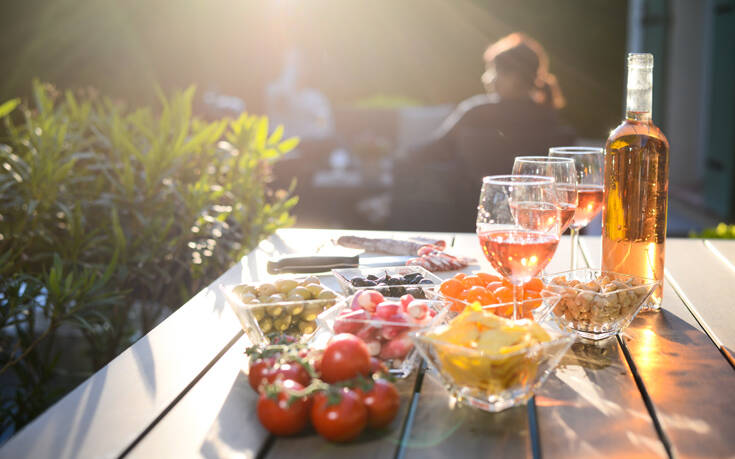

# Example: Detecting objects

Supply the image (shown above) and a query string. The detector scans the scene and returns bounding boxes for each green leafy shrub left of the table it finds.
[0,82,298,430]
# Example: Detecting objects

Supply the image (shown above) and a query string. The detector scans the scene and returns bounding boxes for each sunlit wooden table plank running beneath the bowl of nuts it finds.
[536,237,666,458]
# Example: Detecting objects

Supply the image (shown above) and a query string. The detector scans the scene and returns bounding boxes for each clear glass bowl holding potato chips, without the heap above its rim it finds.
[410,322,575,412]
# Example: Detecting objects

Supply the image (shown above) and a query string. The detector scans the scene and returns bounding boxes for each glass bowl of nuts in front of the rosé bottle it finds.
[537,268,658,340]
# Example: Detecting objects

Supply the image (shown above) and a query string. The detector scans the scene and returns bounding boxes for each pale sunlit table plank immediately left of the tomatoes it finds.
[129,335,268,458]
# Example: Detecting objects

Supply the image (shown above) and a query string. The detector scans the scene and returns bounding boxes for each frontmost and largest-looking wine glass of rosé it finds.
[477,175,561,320]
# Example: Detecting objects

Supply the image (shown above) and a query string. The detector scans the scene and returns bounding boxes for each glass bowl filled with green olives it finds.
[225,276,342,344]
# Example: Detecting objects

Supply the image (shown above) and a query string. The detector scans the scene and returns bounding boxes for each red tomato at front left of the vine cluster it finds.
[256,380,309,435]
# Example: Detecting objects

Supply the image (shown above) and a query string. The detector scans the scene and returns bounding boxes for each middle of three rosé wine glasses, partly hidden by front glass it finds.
[513,156,577,234]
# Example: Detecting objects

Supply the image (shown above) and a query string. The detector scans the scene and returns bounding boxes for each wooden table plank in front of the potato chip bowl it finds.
[403,372,531,458]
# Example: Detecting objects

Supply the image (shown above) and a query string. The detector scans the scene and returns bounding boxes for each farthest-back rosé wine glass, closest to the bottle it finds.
[549,147,605,269]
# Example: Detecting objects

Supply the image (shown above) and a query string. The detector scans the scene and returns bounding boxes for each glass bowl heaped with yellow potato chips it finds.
[411,304,575,412]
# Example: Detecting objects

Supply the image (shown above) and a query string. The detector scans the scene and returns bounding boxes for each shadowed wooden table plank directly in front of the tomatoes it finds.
[266,372,416,459]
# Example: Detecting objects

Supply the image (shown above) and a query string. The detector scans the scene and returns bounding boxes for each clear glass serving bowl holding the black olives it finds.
[332,266,442,299]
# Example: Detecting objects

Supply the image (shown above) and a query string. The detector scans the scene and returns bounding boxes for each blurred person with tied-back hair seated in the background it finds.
[391,32,574,231]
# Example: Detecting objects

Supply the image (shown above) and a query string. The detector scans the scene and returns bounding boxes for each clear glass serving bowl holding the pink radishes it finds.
[316,297,449,378]
